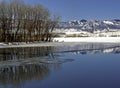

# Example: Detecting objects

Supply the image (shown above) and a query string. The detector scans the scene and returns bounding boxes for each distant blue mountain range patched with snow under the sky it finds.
[57,19,120,32]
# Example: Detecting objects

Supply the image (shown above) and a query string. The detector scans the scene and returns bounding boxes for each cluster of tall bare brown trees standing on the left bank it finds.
[0,0,59,43]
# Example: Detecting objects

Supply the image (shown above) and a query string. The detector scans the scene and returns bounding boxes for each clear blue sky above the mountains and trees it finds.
[0,0,120,21]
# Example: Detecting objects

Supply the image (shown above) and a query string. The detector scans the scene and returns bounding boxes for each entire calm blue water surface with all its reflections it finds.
[0,43,120,88]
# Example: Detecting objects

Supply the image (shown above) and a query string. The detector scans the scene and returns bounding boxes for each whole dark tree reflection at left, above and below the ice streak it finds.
[0,47,60,88]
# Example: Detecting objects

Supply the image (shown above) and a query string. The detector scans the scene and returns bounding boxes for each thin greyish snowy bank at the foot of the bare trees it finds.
[0,42,82,48]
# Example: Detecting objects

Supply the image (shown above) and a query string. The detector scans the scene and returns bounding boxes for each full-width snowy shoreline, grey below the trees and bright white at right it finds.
[0,37,120,48]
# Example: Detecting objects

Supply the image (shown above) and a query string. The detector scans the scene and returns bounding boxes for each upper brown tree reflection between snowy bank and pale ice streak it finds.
[0,47,54,61]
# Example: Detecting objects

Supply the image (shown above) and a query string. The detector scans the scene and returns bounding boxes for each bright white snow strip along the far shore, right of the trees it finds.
[53,37,120,43]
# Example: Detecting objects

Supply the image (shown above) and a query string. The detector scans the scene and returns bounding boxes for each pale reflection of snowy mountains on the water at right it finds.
[56,43,120,55]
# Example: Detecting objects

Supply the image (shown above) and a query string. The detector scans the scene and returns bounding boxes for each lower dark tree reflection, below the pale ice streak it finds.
[0,64,50,87]
